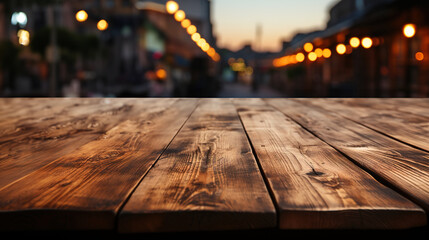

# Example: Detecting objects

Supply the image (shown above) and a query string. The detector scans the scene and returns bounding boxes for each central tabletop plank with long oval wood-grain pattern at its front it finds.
[119,99,276,233]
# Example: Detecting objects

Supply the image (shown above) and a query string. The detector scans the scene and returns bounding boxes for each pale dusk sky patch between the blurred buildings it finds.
[211,0,338,51]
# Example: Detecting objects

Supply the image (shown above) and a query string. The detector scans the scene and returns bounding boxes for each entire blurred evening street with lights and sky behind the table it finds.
[0,0,429,97]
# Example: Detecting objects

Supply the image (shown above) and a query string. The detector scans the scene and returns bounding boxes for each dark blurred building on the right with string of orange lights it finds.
[271,0,429,97]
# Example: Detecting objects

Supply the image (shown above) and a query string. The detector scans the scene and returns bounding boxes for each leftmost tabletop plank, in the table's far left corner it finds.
[0,99,146,189]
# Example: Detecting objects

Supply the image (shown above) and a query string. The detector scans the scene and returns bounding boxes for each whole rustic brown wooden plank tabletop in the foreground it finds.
[0,98,429,234]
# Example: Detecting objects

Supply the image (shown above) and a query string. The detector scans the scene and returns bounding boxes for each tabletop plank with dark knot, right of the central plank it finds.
[234,99,425,229]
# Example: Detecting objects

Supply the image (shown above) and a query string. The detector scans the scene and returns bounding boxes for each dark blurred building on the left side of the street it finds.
[0,0,219,97]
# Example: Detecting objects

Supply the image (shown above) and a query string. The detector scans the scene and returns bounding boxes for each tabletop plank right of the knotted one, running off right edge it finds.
[265,99,429,217]
